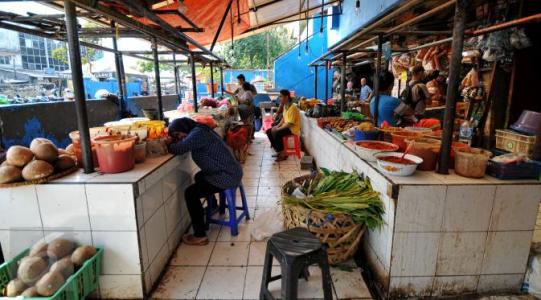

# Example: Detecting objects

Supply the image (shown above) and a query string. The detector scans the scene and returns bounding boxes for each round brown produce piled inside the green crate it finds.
[2,238,97,297]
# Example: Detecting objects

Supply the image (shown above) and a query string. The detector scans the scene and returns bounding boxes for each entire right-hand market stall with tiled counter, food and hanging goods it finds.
[302,1,541,298]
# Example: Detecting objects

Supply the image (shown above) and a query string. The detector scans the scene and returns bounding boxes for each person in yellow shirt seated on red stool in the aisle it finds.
[267,90,301,162]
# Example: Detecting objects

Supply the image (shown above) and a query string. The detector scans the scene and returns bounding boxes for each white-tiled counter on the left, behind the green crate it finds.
[0,155,197,299]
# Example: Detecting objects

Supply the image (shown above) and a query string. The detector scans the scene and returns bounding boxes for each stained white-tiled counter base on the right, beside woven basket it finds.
[302,115,541,298]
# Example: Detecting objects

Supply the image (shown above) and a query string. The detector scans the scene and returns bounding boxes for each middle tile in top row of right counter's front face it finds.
[443,185,496,231]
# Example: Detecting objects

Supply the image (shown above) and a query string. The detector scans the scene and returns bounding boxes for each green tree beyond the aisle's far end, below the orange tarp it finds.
[220,27,295,69]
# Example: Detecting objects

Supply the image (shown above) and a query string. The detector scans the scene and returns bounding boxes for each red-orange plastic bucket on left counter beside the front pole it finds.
[94,135,137,173]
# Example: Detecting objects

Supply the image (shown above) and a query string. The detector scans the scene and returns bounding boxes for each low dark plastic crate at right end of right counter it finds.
[487,160,541,180]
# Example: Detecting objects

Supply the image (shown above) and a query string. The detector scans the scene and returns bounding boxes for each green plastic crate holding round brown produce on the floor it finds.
[0,248,103,300]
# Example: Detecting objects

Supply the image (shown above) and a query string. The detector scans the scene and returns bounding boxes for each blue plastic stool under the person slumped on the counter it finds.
[207,184,250,236]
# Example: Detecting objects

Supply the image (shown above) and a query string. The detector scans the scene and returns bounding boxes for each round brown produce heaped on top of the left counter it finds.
[0,138,77,184]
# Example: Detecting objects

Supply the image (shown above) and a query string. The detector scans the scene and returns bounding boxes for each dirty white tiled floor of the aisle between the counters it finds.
[153,133,371,299]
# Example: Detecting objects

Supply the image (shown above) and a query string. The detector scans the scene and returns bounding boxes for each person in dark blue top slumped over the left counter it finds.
[165,118,242,246]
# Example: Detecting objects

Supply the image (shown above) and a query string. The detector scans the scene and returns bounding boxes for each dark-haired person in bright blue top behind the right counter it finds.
[370,70,400,126]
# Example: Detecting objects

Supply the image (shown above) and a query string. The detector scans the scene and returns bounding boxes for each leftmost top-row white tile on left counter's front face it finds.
[0,185,42,230]
